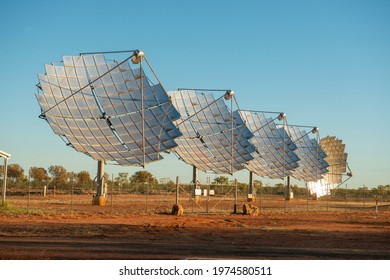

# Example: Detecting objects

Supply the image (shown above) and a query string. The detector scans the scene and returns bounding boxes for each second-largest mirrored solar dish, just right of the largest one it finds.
[169,89,255,174]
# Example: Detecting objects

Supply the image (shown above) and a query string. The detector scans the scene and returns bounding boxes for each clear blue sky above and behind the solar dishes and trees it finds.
[0,0,390,187]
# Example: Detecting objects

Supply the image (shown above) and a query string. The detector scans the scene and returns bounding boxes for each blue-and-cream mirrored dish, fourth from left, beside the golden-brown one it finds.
[288,126,329,182]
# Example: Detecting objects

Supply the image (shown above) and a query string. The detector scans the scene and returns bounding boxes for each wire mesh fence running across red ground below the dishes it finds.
[3,179,390,214]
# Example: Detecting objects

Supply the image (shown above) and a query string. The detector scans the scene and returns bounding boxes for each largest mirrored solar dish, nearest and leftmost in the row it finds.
[36,51,181,166]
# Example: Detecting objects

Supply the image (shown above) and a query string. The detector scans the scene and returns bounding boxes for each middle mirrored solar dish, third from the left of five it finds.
[240,110,299,179]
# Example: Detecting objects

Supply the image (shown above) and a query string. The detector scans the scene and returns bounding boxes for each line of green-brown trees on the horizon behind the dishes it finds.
[0,164,390,197]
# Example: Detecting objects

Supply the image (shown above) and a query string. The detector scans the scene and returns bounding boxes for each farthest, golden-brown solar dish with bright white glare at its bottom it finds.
[309,136,352,197]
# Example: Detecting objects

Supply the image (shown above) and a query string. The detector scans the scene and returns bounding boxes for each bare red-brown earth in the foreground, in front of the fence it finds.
[0,206,390,259]
